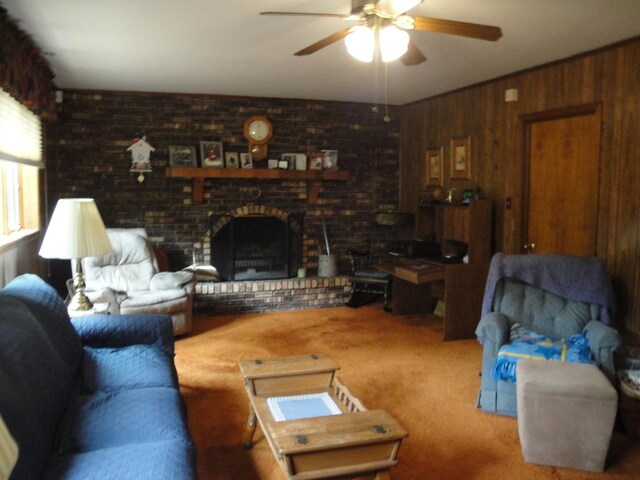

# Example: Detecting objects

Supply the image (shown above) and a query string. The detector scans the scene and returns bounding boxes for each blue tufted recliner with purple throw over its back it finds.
[476,253,620,416]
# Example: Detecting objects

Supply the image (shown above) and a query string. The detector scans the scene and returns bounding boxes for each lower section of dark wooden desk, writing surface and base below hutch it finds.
[376,258,489,340]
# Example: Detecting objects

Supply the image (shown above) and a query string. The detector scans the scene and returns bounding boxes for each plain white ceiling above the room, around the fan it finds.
[0,0,640,105]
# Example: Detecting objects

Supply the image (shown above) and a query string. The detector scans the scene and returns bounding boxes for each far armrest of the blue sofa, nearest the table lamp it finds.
[71,315,174,356]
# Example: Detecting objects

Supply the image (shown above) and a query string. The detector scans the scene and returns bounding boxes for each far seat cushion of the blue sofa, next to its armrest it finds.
[82,344,178,392]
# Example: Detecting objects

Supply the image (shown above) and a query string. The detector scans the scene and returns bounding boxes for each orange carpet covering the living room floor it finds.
[176,304,640,480]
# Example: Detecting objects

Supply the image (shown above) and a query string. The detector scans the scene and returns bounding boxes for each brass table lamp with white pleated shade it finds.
[40,198,113,310]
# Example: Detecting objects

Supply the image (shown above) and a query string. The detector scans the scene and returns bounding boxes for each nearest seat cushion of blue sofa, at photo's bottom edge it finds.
[44,440,197,480]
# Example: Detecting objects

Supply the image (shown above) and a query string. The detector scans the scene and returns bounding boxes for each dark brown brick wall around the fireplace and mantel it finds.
[48,90,408,312]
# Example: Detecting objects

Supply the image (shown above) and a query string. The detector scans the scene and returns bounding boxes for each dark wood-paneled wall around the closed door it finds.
[400,38,640,345]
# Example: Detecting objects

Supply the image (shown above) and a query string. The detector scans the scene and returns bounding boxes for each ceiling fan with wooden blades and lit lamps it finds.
[260,0,502,65]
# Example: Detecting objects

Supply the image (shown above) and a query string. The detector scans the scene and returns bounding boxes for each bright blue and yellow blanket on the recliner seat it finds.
[492,324,596,382]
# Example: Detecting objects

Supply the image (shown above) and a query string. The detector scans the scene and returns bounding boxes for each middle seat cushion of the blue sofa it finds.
[60,388,189,452]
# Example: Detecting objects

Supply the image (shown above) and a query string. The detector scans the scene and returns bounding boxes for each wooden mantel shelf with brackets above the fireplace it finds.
[166,167,349,205]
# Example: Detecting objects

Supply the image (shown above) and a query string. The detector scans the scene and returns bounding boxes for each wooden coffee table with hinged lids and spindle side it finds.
[240,354,407,480]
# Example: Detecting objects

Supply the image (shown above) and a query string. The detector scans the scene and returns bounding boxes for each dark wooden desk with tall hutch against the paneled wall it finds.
[379,200,492,340]
